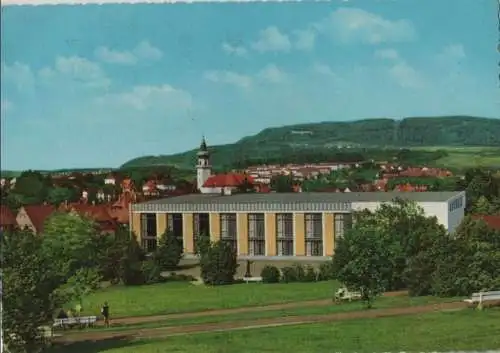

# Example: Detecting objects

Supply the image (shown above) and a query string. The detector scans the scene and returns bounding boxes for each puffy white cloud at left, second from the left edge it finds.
[38,56,111,88]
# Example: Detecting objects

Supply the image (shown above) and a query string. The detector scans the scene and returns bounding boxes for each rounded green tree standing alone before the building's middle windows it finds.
[200,240,238,285]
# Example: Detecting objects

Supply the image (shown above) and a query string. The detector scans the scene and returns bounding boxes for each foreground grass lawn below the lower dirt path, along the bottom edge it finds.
[49,310,500,353]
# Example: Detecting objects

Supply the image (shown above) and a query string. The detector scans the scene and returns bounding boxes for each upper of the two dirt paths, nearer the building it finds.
[92,291,407,326]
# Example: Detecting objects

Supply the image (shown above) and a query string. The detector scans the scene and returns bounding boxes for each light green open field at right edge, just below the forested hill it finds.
[412,146,500,169]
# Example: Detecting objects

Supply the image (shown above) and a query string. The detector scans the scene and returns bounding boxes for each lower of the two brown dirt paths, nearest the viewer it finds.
[56,296,464,342]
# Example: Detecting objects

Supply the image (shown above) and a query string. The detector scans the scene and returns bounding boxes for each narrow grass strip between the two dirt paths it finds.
[72,297,461,333]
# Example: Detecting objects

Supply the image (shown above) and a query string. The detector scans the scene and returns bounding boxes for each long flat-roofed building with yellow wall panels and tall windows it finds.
[130,192,465,259]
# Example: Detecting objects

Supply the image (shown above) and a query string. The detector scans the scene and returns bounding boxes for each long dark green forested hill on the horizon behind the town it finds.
[123,116,500,169]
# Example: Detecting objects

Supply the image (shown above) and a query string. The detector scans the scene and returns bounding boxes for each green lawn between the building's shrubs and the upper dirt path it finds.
[74,281,337,318]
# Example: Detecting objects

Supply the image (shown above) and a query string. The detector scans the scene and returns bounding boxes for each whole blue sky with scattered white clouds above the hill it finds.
[1,0,500,170]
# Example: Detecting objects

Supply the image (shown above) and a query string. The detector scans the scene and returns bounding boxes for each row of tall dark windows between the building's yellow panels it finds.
[141,213,351,256]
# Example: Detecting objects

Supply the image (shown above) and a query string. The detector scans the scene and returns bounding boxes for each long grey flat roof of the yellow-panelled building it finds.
[132,191,464,212]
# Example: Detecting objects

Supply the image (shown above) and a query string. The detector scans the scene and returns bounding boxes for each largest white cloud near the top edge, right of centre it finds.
[315,8,417,45]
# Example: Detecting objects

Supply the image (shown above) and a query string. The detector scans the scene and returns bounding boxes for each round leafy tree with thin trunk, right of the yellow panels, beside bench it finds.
[333,226,393,308]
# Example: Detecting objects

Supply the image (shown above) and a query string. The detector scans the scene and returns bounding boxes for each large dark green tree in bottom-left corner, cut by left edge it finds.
[1,227,63,353]
